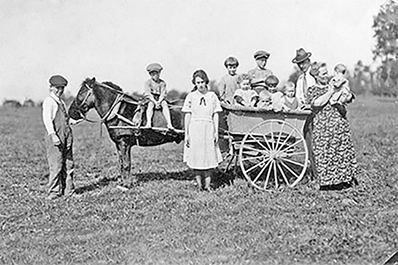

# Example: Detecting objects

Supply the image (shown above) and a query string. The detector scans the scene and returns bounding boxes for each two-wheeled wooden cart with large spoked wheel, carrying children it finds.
[220,104,311,190]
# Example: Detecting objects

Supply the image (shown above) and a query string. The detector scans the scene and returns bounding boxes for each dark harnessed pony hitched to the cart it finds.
[69,77,184,186]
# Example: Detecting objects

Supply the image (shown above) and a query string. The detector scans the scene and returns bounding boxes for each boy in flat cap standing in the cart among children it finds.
[248,50,272,93]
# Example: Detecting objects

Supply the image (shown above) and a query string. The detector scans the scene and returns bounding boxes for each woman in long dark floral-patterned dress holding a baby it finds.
[306,64,357,190]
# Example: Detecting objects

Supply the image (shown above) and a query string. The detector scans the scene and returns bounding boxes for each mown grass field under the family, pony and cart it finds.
[0,98,398,264]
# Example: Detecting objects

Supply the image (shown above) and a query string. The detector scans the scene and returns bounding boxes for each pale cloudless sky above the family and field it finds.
[0,0,385,103]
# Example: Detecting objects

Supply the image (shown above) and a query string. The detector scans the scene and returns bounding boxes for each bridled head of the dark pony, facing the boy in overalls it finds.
[69,77,97,120]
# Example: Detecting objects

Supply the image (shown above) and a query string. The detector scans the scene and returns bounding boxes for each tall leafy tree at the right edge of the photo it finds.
[373,0,398,95]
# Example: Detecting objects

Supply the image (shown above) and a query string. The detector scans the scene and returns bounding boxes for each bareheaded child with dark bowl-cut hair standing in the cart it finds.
[218,57,239,104]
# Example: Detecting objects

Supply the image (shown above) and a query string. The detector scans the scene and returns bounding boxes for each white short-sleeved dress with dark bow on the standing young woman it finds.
[181,90,222,169]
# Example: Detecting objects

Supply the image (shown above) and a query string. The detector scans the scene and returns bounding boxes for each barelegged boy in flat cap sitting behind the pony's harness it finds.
[144,63,174,129]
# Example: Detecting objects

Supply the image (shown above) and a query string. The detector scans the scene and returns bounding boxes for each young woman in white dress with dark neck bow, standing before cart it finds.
[182,70,222,190]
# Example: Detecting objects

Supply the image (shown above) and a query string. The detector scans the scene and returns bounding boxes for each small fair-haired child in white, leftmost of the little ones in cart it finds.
[234,74,258,107]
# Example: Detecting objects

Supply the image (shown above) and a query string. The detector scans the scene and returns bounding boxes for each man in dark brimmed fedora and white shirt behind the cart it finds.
[292,48,315,104]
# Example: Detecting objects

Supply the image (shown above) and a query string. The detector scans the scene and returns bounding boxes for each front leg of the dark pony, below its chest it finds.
[117,140,136,187]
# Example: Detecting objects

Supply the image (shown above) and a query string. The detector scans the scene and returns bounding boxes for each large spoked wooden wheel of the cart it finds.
[238,120,308,190]
